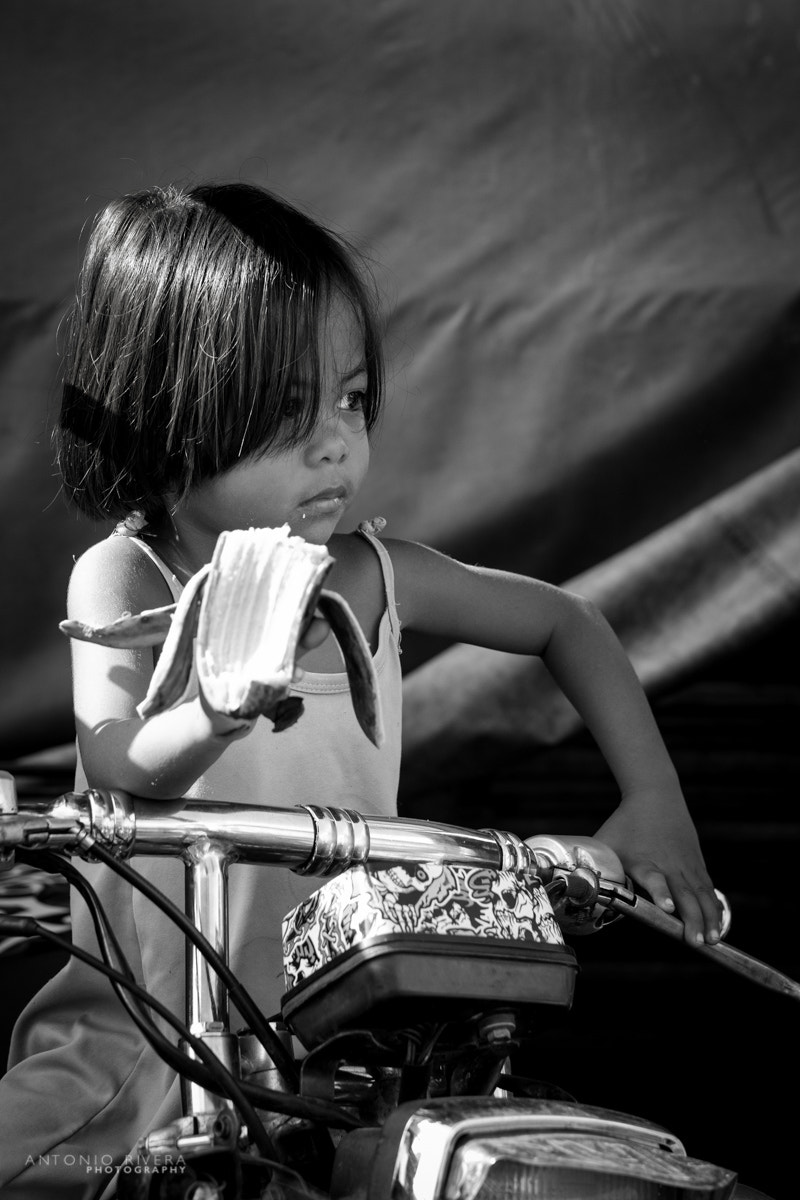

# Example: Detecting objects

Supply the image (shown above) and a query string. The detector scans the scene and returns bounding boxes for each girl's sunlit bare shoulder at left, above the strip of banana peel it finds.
[67,535,173,624]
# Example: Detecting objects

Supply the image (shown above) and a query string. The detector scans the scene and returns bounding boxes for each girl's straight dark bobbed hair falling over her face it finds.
[55,184,383,517]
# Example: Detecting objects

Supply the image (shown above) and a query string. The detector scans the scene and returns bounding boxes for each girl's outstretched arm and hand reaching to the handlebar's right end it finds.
[386,540,721,942]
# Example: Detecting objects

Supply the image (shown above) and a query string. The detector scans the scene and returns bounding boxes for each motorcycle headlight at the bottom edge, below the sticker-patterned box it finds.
[332,1097,736,1200]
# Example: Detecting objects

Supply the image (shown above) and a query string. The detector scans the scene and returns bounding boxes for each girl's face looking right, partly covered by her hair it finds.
[181,300,369,545]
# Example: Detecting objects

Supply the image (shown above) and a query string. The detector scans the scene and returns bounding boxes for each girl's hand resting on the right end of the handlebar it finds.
[596,788,722,944]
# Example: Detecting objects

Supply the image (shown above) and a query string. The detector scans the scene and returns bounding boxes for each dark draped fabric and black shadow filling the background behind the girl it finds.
[0,7,800,1196]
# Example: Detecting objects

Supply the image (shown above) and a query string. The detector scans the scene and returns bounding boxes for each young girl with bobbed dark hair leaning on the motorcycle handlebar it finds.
[0,185,720,1198]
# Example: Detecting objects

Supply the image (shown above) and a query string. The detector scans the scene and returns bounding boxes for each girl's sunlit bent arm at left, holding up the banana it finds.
[67,538,253,799]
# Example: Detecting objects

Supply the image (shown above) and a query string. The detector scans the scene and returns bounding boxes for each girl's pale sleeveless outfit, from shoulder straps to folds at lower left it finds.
[0,530,402,1196]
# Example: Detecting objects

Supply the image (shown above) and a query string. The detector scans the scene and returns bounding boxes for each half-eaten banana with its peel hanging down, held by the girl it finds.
[59,526,384,746]
